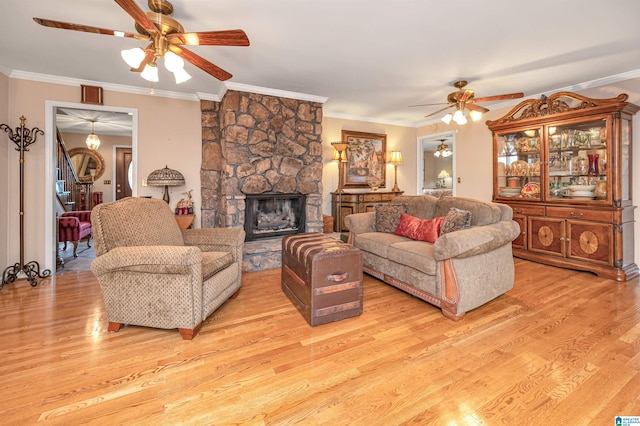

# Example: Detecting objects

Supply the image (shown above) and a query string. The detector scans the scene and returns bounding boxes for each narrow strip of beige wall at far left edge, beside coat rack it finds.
[0,72,8,270]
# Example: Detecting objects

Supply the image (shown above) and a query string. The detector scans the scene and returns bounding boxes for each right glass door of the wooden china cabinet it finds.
[545,118,609,201]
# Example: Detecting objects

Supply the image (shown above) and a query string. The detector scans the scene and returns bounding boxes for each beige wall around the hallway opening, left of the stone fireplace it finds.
[2,79,202,268]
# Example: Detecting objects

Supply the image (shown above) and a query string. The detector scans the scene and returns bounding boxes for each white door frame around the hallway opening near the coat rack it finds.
[43,101,138,271]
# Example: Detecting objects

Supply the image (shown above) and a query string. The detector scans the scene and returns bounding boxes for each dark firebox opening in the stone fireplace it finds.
[244,194,306,241]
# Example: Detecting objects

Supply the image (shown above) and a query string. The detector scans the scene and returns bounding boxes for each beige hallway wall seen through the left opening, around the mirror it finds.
[62,133,133,203]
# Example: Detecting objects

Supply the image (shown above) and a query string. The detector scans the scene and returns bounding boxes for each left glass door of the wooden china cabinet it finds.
[496,128,542,200]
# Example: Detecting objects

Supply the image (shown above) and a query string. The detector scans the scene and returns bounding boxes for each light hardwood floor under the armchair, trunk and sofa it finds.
[0,259,640,425]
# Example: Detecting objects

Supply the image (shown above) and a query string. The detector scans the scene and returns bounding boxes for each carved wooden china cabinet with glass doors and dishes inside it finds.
[487,92,640,281]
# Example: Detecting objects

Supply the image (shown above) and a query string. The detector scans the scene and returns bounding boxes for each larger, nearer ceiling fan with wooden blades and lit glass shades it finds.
[33,0,249,83]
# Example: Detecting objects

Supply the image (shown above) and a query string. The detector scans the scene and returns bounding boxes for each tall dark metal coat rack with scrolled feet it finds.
[0,116,51,290]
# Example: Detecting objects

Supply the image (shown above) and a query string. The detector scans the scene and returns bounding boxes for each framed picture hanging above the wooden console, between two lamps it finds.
[342,130,387,188]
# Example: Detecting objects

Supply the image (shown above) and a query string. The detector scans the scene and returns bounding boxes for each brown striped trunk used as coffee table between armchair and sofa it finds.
[282,233,362,326]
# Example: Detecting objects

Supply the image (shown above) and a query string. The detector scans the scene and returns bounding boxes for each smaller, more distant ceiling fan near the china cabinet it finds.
[410,80,524,124]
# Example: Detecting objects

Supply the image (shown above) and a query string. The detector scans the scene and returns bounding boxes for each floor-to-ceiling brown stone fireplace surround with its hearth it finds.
[200,90,323,271]
